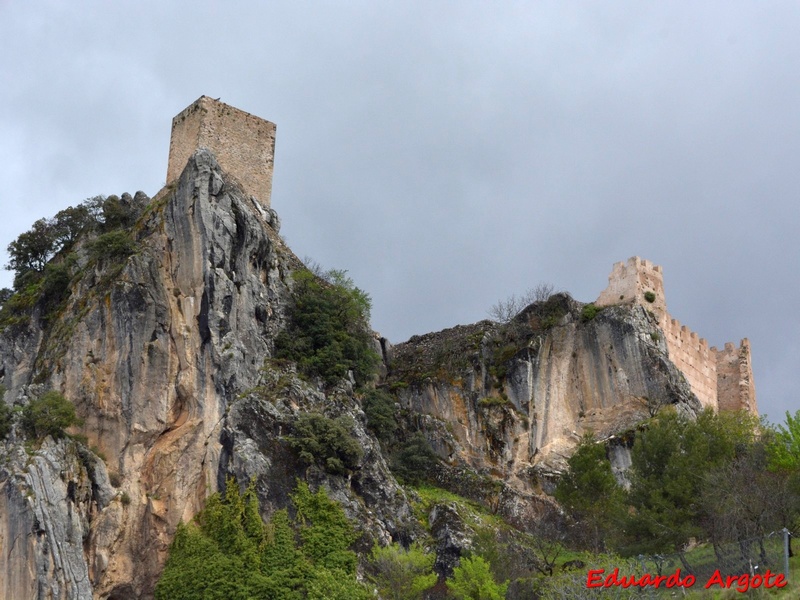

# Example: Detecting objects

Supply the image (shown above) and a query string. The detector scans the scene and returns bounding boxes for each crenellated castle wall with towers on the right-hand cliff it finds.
[595,256,758,414]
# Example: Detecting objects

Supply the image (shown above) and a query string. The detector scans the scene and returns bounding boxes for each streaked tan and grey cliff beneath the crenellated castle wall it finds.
[389,295,701,496]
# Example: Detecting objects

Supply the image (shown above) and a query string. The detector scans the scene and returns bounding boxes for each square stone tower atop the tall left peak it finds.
[167,96,275,210]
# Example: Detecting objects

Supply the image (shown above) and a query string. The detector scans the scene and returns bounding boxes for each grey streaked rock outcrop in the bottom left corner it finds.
[0,438,114,600]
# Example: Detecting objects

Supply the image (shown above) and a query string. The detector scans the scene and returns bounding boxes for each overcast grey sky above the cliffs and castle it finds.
[0,0,800,421]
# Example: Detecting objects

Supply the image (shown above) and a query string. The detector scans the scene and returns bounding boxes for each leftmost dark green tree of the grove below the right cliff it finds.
[555,434,624,552]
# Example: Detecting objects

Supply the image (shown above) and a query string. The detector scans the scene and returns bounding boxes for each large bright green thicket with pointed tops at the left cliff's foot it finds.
[156,480,371,600]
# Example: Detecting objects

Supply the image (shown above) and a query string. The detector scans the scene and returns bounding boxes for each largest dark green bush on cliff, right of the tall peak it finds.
[275,270,379,385]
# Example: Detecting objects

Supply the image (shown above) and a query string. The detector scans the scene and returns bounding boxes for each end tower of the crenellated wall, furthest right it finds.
[711,338,758,415]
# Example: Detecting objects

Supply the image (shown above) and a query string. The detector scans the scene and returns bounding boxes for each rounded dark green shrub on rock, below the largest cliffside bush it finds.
[288,413,364,475]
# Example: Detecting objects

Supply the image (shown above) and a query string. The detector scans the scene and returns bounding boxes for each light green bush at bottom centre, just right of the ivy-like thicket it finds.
[369,544,437,600]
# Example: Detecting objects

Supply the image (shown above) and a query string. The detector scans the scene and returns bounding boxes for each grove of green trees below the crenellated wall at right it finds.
[556,409,800,555]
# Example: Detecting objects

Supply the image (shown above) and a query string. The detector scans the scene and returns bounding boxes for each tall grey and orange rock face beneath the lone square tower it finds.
[0,150,410,600]
